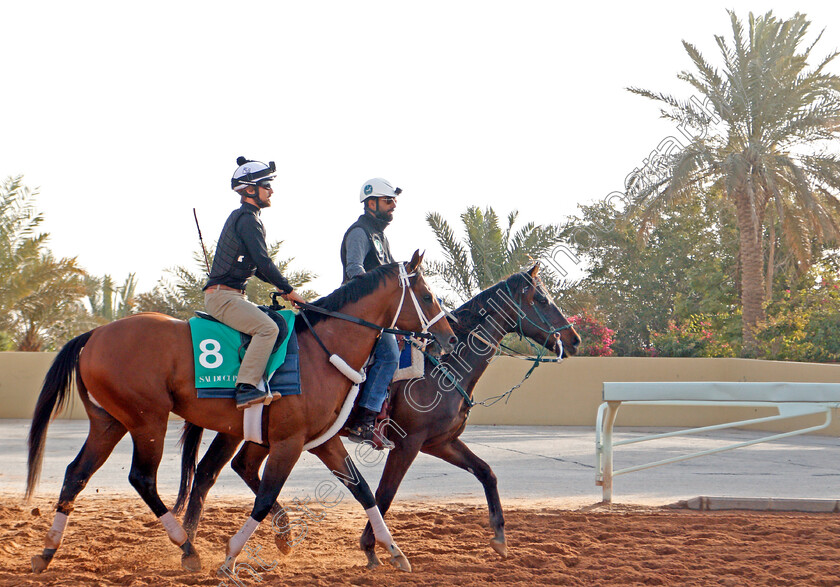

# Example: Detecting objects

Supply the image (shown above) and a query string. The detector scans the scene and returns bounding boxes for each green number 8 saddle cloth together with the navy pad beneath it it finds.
[189,310,300,398]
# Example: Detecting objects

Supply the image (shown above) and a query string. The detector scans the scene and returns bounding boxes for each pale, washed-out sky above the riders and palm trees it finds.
[0,0,840,295]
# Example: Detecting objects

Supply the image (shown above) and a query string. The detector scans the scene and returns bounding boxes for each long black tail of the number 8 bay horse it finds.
[26,330,93,500]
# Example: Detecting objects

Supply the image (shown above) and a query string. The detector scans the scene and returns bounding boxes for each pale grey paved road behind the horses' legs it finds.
[0,420,840,507]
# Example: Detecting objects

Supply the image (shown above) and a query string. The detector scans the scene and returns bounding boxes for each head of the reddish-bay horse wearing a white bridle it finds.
[394,250,458,354]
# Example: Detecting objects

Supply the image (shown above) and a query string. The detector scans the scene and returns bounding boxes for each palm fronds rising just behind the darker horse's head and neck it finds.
[426,206,561,301]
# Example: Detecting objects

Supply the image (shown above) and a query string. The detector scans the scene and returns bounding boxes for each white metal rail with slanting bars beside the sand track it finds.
[595,381,840,502]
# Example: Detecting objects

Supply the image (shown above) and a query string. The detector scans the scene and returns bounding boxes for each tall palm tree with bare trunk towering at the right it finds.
[628,11,840,355]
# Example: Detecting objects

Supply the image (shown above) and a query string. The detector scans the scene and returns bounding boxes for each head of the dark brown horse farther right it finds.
[504,262,580,357]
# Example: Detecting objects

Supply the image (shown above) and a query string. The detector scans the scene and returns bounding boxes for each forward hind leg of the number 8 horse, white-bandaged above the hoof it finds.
[128,418,201,572]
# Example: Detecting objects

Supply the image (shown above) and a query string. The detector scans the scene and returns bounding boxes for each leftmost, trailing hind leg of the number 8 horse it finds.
[31,406,126,573]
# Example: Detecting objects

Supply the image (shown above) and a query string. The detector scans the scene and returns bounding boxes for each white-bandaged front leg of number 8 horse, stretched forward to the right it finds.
[310,436,411,573]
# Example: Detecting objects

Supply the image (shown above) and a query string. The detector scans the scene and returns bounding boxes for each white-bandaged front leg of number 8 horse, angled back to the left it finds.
[218,434,304,577]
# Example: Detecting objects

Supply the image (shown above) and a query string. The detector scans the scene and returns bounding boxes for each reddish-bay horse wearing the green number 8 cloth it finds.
[26,251,457,573]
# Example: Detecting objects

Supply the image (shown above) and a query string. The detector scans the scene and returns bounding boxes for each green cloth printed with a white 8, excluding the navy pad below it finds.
[189,310,295,397]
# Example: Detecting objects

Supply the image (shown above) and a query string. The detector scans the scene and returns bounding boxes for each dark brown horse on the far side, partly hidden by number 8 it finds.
[171,263,580,568]
